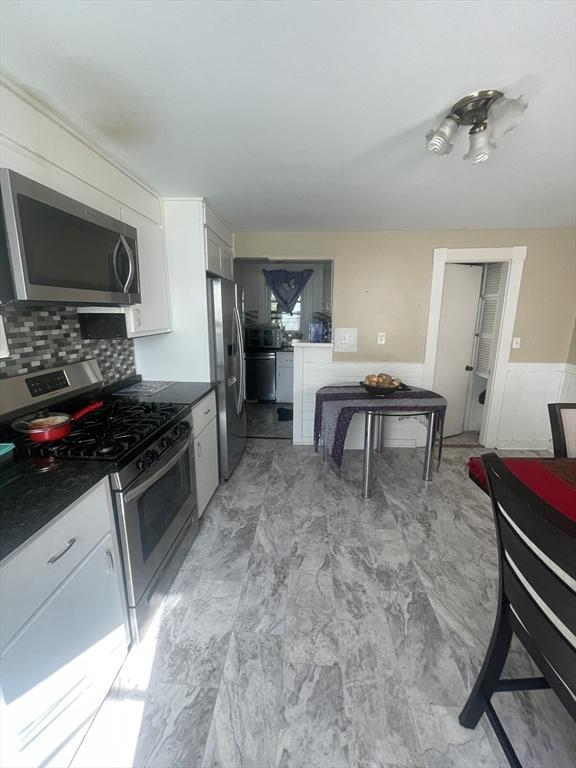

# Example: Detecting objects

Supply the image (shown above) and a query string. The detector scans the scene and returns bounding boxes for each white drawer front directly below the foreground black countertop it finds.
[0,478,112,647]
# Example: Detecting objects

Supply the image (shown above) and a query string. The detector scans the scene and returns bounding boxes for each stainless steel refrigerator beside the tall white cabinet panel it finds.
[208,277,247,480]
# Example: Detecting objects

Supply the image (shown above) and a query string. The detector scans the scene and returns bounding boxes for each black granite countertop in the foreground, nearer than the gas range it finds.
[0,459,110,561]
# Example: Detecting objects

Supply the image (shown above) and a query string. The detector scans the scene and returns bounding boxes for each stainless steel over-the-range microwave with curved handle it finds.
[0,168,141,305]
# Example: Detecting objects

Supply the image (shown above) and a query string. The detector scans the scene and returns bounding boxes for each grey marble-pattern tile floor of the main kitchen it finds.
[73,440,576,768]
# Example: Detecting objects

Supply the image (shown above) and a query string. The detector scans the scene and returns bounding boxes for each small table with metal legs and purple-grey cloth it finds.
[314,384,447,499]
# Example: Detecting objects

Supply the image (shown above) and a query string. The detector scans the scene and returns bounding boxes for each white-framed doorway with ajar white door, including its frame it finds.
[423,246,526,448]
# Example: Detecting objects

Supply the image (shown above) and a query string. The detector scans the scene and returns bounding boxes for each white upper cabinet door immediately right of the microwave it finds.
[122,208,170,338]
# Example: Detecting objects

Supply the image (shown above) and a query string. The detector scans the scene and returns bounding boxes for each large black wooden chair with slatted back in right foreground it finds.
[459,454,576,768]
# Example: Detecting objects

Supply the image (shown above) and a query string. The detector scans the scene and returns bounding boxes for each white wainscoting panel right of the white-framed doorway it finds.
[498,363,576,450]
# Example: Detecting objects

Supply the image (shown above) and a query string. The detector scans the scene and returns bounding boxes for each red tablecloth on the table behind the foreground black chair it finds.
[468,456,576,523]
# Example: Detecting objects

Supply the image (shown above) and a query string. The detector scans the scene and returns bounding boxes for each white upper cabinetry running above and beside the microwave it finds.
[0,83,171,338]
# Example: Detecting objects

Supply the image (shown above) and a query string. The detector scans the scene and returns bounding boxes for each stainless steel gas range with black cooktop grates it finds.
[0,360,198,640]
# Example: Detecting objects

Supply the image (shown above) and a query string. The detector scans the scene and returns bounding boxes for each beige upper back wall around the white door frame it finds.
[236,228,576,363]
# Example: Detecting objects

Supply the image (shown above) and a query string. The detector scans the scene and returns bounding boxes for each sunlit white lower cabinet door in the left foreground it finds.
[0,478,128,768]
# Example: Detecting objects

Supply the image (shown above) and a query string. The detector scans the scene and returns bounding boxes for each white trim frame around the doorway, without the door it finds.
[422,245,528,448]
